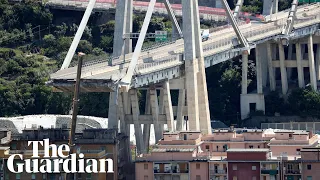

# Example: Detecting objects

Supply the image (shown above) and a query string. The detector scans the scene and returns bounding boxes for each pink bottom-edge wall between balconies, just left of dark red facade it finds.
[190,162,209,180]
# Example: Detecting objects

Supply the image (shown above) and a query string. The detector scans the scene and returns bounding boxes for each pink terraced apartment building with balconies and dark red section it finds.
[135,128,320,180]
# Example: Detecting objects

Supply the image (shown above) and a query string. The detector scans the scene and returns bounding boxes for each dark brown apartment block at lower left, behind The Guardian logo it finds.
[0,127,127,180]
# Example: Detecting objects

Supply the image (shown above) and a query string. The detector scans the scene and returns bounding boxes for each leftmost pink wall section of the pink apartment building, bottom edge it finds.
[135,162,154,180]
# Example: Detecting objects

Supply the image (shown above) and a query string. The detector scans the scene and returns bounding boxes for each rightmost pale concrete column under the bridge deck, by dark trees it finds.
[308,34,317,91]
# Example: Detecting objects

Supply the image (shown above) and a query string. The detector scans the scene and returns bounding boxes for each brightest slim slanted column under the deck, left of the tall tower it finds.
[163,81,175,132]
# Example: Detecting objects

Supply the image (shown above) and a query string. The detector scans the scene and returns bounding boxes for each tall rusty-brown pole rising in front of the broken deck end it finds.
[67,52,85,180]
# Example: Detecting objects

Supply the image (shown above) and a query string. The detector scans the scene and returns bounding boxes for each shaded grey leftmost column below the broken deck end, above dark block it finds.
[108,92,119,128]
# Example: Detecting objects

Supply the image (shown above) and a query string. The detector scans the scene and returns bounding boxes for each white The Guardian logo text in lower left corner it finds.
[7,139,114,173]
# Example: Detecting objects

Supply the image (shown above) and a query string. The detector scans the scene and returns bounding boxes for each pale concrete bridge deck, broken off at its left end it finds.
[50,4,320,91]
